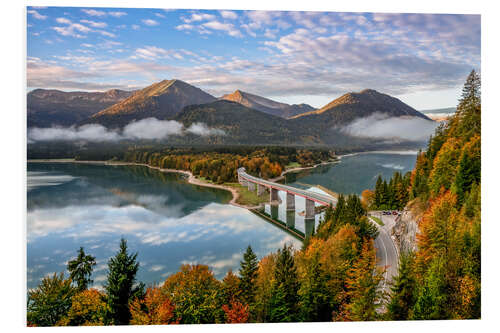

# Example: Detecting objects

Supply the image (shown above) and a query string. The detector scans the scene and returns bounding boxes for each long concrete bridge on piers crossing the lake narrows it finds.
[238,167,337,219]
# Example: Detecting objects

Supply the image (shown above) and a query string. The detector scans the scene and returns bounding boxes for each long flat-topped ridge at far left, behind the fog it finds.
[27,89,133,127]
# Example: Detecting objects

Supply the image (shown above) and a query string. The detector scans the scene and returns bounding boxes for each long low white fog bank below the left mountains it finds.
[28,118,225,143]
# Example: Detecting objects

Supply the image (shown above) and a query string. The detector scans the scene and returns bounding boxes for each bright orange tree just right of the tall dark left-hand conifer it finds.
[130,287,179,325]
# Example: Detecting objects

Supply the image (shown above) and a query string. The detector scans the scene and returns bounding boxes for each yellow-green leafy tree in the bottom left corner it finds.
[27,273,77,326]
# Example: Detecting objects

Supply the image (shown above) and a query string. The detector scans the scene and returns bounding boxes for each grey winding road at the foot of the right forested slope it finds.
[368,212,399,300]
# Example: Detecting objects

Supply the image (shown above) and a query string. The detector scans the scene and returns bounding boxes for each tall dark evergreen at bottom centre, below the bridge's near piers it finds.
[270,244,299,322]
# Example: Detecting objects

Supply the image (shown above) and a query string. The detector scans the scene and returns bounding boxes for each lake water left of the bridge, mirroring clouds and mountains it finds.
[27,163,301,288]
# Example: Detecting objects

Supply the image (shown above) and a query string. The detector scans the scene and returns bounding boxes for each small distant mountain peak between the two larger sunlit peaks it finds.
[220,90,315,118]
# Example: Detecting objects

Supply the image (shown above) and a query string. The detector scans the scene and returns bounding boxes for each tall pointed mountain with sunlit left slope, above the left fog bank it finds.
[82,79,216,128]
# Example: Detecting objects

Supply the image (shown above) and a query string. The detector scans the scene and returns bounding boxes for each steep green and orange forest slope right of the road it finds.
[382,71,481,320]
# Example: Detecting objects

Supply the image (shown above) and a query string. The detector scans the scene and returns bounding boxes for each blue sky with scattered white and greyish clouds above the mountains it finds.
[27,7,481,110]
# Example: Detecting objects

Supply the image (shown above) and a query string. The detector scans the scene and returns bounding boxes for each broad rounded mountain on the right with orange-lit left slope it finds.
[291,89,430,129]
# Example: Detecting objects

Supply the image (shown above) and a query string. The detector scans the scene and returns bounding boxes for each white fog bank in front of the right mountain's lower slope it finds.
[341,112,439,141]
